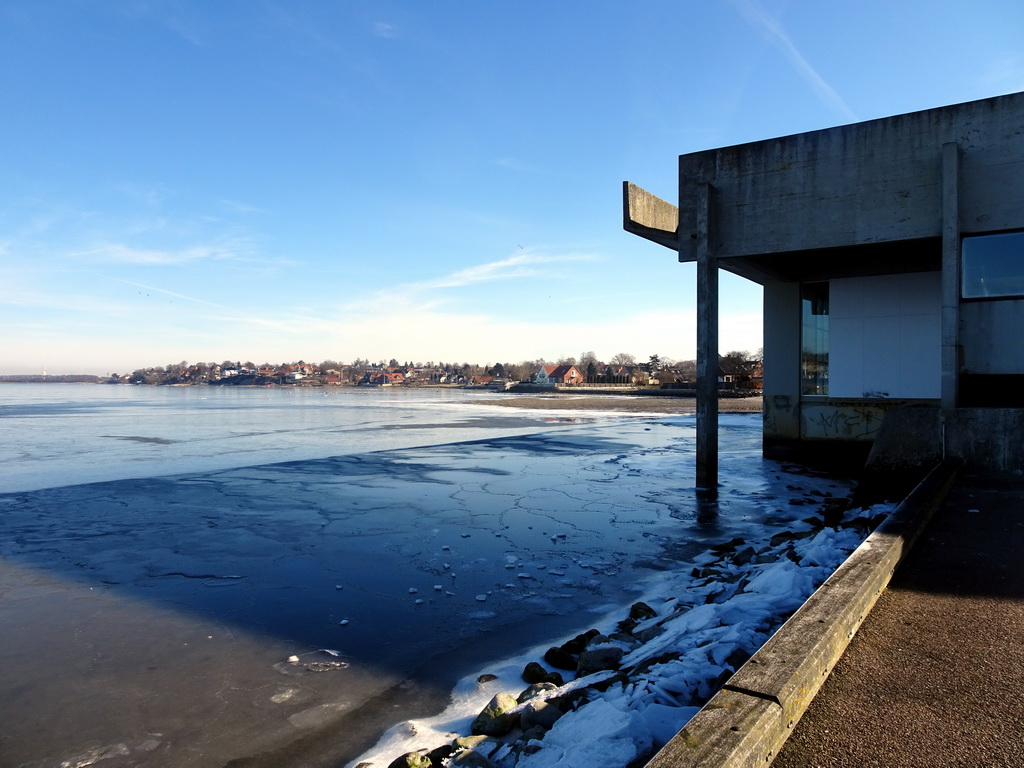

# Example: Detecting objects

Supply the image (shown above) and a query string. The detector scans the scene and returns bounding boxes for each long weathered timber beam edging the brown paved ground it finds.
[647,459,959,768]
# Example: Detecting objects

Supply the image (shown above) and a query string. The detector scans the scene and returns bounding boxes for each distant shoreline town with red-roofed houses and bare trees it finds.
[0,350,762,390]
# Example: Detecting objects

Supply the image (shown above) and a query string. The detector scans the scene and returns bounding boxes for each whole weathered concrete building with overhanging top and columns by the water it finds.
[624,93,1024,486]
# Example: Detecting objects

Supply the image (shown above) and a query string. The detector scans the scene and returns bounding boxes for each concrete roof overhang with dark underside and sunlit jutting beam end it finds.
[623,93,1024,284]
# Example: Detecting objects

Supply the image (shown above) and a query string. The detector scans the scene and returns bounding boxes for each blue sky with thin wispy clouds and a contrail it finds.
[0,0,1024,374]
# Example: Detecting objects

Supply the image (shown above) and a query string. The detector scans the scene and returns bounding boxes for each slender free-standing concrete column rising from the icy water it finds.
[694,184,718,495]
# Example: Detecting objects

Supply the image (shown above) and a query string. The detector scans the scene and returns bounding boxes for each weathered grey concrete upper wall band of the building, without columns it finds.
[679,93,1024,261]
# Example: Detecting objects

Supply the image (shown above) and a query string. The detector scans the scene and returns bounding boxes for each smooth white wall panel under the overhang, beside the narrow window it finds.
[828,272,942,398]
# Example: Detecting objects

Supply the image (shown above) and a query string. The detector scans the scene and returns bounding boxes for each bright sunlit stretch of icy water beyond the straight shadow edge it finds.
[0,384,609,493]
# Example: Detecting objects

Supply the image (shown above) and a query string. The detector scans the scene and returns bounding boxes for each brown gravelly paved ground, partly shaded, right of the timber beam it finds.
[772,478,1024,768]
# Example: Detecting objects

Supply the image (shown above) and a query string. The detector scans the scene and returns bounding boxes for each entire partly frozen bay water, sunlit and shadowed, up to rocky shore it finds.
[0,384,831,768]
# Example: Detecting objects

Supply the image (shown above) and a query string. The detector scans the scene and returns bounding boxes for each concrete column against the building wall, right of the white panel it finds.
[941,142,961,415]
